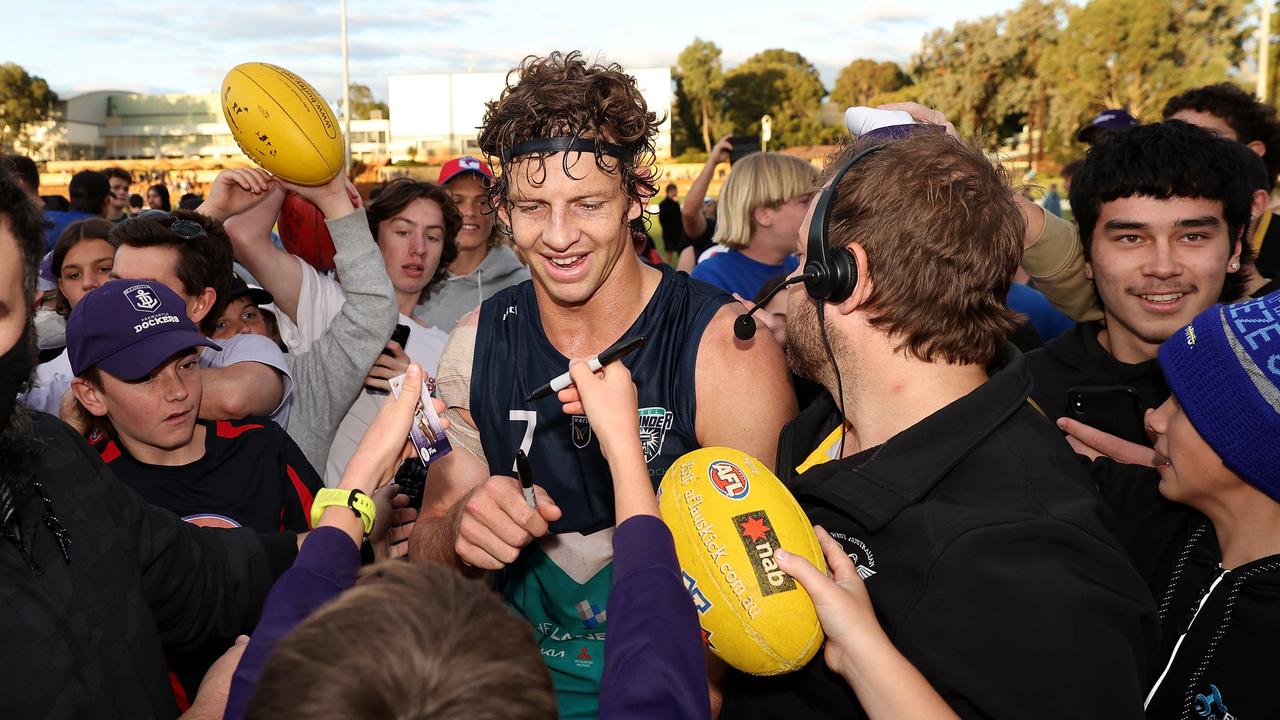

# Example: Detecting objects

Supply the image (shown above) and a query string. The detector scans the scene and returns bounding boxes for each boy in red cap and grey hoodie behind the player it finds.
[413,155,529,333]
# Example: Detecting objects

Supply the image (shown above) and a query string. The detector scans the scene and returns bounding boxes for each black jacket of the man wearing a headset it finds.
[722,348,1158,719]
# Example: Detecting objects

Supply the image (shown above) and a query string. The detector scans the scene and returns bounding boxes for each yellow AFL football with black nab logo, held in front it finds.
[658,447,827,675]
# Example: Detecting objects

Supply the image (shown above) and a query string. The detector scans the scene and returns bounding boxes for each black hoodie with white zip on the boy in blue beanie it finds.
[1094,460,1280,720]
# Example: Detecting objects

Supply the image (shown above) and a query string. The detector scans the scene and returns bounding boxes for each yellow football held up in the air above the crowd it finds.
[223,63,343,186]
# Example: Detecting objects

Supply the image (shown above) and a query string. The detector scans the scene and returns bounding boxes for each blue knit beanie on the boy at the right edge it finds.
[1160,286,1280,501]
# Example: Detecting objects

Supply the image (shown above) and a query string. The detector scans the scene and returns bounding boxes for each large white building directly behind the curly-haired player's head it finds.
[388,68,675,161]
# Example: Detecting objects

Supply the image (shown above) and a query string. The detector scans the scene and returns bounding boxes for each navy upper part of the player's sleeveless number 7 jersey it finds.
[471,265,733,533]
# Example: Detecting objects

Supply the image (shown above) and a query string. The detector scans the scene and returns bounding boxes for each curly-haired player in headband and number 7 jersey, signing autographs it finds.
[411,53,795,717]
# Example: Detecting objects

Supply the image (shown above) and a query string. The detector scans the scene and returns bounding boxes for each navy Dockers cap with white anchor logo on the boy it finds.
[67,279,221,380]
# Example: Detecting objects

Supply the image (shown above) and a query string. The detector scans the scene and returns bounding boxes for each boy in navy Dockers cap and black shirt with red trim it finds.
[67,279,323,533]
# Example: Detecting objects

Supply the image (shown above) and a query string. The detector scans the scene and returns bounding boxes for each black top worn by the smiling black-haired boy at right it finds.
[1027,322,1169,445]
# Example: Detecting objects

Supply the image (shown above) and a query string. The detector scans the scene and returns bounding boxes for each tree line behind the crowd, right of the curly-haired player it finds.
[672,0,1254,160]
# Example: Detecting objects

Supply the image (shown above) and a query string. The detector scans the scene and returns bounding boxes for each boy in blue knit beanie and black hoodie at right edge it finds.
[1093,286,1280,720]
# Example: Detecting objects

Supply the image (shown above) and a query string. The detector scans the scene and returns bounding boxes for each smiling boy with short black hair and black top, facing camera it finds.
[1027,120,1252,430]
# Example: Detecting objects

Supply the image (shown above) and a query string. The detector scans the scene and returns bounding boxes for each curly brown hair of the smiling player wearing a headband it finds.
[480,50,662,208]
